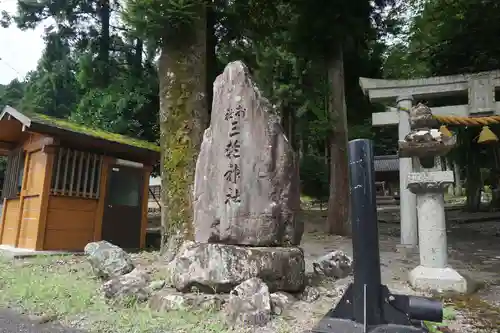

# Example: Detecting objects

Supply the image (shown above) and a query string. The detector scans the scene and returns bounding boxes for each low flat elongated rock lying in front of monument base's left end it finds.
[149,289,226,311]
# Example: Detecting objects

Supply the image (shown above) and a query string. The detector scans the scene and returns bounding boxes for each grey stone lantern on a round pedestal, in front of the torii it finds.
[399,104,467,292]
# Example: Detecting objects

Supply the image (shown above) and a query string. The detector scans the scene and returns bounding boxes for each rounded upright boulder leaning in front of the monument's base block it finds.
[224,278,271,326]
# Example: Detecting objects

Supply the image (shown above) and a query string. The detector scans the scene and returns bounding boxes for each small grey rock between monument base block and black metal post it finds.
[313,251,352,279]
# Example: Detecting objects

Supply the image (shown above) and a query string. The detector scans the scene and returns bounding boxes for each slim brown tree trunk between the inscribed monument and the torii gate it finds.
[327,43,349,235]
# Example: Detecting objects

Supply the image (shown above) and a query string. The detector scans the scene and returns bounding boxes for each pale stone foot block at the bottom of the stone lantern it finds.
[410,266,468,293]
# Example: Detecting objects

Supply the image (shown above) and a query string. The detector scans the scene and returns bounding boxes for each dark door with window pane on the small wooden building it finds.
[102,165,144,249]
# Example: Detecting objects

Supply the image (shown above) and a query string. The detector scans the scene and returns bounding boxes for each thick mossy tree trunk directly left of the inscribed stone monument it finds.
[158,4,208,261]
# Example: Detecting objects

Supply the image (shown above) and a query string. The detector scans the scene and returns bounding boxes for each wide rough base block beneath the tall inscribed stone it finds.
[168,241,305,293]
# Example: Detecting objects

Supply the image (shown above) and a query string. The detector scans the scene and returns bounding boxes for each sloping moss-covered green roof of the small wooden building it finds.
[22,111,160,152]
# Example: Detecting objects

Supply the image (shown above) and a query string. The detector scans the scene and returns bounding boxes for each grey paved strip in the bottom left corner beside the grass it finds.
[0,309,85,333]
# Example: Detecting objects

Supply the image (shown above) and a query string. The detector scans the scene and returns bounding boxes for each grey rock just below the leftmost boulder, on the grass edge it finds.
[102,268,149,302]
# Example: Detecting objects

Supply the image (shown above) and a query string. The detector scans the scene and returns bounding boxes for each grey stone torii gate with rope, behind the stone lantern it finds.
[359,71,500,248]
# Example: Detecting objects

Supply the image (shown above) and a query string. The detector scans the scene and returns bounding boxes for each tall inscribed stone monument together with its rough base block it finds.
[171,61,305,292]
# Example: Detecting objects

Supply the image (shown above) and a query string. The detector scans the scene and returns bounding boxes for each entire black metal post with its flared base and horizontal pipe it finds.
[311,139,443,333]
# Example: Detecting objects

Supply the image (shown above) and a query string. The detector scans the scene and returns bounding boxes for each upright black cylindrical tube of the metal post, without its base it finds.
[349,139,382,325]
